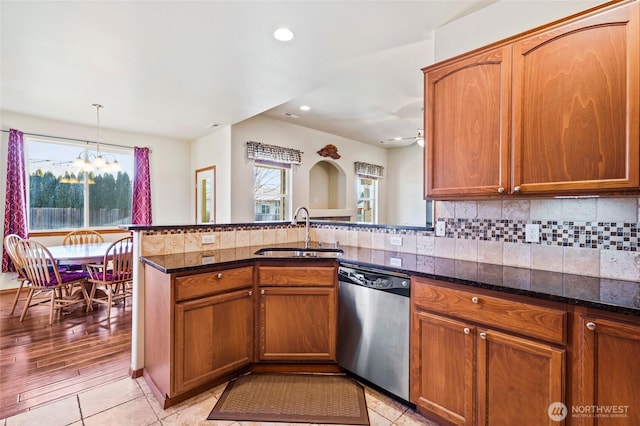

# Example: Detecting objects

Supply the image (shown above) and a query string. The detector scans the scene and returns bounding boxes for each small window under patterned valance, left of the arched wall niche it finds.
[253,161,290,222]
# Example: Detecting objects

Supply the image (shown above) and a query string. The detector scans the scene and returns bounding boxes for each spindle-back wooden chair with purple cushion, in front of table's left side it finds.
[15,239,88,325]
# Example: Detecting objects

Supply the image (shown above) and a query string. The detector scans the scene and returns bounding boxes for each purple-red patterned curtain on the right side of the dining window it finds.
[131,146,151,225]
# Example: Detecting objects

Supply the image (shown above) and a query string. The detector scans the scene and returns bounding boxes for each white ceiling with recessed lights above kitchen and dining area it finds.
[0,0,495,147]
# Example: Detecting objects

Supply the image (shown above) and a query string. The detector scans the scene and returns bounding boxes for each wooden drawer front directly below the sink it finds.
[258,266,337,287]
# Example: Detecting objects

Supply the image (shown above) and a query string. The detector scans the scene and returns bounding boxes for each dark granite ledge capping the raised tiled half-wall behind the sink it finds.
[118,220,434,232]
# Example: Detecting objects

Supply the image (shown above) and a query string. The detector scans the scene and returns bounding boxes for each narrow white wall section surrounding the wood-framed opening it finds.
[190,126,232,223]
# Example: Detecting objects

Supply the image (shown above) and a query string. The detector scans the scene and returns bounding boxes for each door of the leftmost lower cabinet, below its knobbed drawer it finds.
[175,289,254,393]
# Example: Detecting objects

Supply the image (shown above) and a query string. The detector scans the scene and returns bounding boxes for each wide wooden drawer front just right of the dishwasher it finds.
[413,281,567,344]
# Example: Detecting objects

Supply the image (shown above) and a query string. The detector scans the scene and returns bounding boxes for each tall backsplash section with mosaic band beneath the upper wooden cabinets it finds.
[424,197,640,281]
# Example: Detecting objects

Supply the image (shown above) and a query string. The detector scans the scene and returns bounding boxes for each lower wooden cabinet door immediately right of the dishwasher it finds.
[410,311,476,425]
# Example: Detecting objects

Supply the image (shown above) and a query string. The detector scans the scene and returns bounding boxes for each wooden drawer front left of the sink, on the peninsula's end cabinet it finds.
[176,266,253,300]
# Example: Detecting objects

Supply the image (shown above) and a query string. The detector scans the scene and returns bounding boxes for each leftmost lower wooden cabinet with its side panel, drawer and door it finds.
[143,264,255,408]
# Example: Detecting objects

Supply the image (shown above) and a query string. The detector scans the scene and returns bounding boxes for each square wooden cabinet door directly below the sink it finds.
[258,287,337,361]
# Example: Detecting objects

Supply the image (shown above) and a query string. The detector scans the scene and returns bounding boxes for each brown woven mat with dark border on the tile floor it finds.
[207,373,369,425]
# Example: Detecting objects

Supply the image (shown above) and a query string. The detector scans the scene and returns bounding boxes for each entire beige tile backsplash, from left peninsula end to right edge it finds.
[141,197,640,281]
